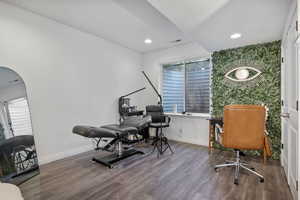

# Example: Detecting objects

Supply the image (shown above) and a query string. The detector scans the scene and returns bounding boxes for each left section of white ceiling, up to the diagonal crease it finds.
[5,0,187,52]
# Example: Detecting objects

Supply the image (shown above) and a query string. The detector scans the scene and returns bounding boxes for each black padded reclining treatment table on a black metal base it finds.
[73,116,151,168]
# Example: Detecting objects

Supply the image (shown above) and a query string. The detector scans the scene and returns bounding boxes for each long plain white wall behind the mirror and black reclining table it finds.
[0,2,143,163]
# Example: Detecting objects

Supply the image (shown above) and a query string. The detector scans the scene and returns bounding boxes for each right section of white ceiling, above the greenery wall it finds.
[192,0,291,51]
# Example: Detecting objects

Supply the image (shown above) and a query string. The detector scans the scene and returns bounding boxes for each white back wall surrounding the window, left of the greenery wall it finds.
[143,43,210,146]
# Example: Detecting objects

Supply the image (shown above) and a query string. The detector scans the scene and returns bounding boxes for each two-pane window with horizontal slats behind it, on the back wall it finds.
[162,59,211,113]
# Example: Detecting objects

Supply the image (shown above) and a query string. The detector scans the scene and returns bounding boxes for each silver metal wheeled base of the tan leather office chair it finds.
[215,151,264,185]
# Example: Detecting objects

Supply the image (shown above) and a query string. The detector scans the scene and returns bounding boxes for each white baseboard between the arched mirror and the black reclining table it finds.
[39,145,93,165]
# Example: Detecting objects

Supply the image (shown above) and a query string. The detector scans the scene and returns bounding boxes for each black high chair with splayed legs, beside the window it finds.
[146,105,173,157]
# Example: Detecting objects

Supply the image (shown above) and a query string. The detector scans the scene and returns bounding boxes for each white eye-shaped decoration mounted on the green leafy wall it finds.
[225,66,261,82]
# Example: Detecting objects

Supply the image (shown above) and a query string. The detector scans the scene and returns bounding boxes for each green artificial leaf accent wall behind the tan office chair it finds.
[212,41,281,159]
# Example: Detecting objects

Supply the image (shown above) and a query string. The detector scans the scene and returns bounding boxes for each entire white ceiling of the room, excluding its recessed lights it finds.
[2,0,293,52]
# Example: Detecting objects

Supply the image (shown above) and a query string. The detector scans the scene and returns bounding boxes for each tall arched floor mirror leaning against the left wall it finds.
[0,67,39,185]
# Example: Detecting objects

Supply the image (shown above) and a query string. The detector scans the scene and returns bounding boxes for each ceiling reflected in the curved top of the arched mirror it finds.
[0,67,24,89]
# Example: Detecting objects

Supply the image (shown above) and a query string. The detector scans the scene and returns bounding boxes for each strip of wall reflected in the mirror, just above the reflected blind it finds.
[0,83,26,102]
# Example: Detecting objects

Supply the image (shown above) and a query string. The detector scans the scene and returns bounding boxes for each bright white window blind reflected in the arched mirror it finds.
[8,98,32,136]
